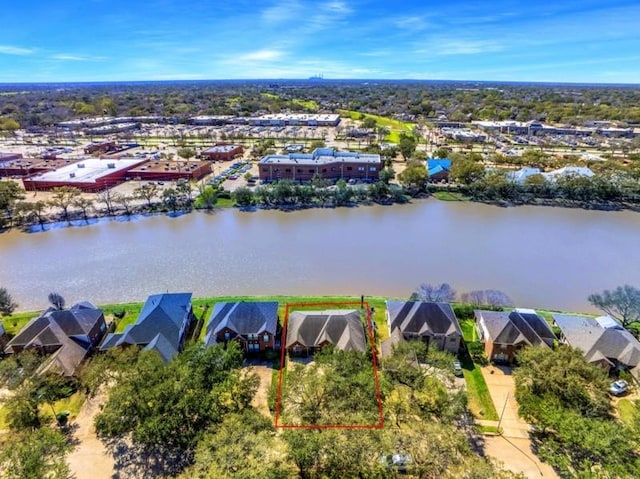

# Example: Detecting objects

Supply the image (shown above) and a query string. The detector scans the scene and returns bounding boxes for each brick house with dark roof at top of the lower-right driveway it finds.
[474,308,557,363]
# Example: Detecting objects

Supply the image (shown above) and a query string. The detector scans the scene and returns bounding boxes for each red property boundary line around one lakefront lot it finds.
[274,301,384,429]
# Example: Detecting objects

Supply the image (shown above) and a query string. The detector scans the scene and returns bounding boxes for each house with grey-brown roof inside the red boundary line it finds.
[287,310,367,356]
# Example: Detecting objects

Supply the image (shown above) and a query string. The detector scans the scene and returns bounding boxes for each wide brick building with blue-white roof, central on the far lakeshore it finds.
[259,148,383,181]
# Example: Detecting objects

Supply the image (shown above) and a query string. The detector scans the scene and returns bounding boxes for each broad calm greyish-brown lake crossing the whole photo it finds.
[0,199,640,311]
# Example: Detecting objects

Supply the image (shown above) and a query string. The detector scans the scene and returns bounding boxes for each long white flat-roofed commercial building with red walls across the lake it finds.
[22,158,147,192]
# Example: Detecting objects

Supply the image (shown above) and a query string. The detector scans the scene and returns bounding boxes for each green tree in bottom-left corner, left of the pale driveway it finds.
[0,428,71,479]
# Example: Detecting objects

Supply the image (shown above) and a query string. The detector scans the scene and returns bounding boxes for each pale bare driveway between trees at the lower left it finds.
[67,394,114,479]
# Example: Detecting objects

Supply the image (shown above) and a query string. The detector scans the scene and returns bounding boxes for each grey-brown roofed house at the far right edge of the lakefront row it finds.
[553,314,640,377]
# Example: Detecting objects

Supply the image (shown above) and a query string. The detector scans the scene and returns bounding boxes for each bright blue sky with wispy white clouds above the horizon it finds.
[0,0,640,83]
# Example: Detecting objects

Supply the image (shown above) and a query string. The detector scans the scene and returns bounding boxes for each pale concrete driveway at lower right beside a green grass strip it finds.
[482,366,558,478]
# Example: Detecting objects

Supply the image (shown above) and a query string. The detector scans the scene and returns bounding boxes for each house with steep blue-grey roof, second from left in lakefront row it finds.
[100,293,194,362]
